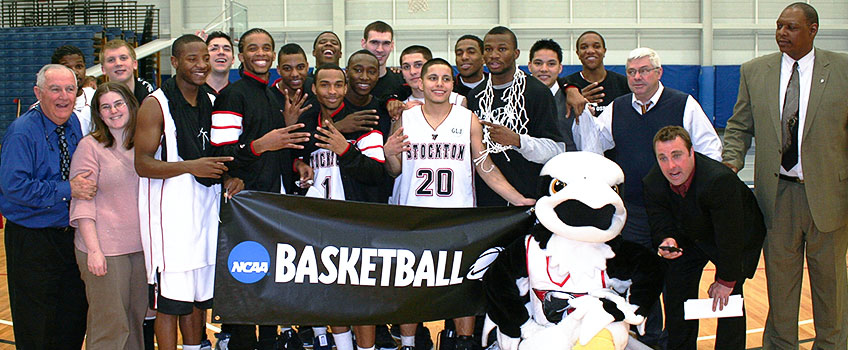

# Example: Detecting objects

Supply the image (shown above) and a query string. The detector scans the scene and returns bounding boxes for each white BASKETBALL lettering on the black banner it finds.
[274,243,463,287]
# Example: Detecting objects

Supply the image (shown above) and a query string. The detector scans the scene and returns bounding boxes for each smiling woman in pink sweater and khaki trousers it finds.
[70,83,147,349]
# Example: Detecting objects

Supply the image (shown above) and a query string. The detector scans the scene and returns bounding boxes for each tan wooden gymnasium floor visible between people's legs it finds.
[0,139,836,349]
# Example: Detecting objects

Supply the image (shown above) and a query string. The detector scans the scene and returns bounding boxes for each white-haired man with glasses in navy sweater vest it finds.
[572,47,721,345]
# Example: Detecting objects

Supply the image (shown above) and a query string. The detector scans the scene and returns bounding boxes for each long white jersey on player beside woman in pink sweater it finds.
[138,89,221,284]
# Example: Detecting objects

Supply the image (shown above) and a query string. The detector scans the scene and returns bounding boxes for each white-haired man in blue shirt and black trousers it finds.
[0,64,97,349]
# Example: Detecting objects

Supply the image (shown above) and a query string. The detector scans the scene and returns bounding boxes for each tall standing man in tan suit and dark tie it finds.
[723,3,848,349]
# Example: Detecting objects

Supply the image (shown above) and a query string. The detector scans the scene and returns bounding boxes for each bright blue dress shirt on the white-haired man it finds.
[0,106,82,228]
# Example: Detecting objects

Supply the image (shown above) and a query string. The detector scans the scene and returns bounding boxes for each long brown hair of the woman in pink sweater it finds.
[91,82,138,149]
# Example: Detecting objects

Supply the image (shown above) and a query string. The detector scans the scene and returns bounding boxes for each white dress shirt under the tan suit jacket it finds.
[778,50,816,179]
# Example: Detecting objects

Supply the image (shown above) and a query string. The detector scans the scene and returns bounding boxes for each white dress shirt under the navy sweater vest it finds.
[571,83,724,161]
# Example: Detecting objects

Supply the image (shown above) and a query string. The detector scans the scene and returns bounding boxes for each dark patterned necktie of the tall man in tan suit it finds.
[780,62,801,171]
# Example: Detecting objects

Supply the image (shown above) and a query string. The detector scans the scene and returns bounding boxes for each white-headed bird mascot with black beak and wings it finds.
[475,152,664,350]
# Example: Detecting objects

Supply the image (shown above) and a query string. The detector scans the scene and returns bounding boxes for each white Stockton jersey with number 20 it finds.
[389,105,476,208]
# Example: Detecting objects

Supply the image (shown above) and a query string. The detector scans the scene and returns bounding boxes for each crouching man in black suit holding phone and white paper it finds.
[642,126,766,350]
